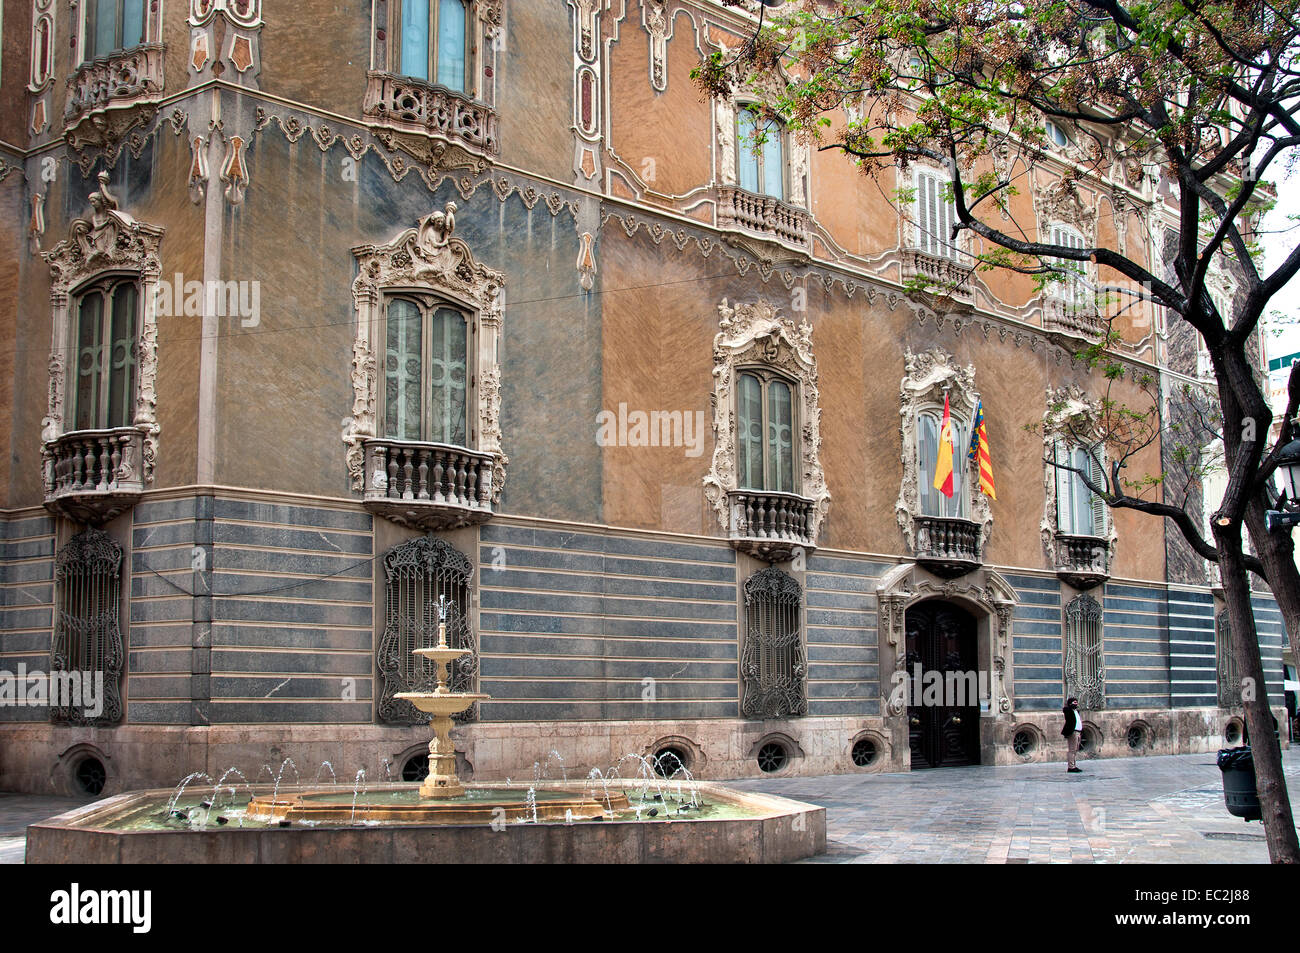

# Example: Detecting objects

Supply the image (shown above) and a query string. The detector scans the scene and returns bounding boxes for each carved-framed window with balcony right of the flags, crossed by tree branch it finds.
[1040,386,1118,589]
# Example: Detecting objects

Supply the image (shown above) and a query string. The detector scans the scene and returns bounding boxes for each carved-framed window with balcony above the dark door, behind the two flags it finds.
[894,347,993,576]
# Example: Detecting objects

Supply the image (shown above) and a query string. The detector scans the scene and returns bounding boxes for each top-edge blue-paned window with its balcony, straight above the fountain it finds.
[361,0,504,173]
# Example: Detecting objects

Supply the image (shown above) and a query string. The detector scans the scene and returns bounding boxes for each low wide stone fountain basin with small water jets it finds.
[26,780,826,863]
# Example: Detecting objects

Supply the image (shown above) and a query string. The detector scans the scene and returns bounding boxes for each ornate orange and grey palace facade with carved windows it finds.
[0,0,1283,792]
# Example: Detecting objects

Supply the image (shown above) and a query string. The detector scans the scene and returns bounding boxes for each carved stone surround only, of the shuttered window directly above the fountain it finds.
[343,202,508,502]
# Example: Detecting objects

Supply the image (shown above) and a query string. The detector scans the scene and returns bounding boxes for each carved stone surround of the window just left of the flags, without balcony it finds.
[705,293,831,558]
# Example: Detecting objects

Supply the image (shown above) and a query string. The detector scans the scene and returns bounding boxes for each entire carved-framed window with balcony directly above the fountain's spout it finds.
[343,203,508,529]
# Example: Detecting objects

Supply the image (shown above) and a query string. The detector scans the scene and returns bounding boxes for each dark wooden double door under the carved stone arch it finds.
[906,602,979,768]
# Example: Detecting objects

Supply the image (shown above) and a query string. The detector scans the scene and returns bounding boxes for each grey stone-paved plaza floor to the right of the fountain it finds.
[731,749,1300,863]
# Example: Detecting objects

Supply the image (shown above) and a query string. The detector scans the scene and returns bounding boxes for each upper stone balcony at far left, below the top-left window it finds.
[64,43,165,150]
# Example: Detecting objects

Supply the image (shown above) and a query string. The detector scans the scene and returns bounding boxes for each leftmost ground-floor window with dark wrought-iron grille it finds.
[49,528,124,725]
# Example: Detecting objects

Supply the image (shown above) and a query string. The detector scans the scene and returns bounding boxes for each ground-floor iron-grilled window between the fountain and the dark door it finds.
[740,567,809,718]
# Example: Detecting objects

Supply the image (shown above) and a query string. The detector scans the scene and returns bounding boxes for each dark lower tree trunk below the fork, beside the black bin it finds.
[1214,523,1300,863]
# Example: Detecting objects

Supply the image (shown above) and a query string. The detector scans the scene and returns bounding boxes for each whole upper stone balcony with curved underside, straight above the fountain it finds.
[361,70,501,168]
